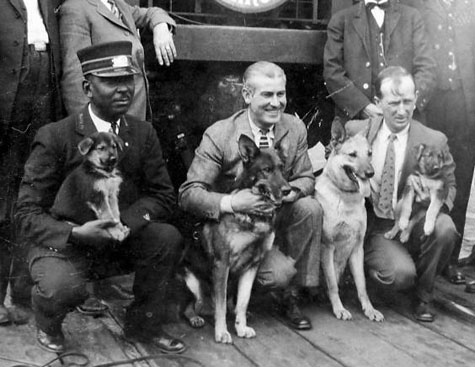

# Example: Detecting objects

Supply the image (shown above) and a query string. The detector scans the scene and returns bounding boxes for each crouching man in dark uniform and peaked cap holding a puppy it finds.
[15,41,185,353]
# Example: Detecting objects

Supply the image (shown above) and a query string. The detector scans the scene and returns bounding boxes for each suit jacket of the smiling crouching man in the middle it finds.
[178,109,315,219]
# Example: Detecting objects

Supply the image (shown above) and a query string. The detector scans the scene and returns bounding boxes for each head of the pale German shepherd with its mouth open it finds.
[326,128,374,196]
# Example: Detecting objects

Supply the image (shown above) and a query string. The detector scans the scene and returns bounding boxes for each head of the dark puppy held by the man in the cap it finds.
[78,132,123,173]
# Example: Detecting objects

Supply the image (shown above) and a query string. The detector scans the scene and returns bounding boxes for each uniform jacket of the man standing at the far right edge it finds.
[423,0,475,123]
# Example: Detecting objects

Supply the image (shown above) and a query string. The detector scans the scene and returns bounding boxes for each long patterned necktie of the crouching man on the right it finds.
[378,134,397,219]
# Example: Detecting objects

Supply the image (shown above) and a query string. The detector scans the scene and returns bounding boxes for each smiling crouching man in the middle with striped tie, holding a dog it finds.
[178,61,322,330]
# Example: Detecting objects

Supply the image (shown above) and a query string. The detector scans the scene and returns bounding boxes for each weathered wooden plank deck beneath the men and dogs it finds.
[0,268,475,367]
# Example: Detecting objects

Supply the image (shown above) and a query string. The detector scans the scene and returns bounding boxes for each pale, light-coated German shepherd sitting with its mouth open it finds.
[315,129,384,321]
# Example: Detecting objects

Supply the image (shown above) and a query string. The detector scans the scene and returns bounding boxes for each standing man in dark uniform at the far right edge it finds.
[424,0,475,276]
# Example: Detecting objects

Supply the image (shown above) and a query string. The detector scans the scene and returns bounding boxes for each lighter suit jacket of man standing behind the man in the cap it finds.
[59,0,175,120]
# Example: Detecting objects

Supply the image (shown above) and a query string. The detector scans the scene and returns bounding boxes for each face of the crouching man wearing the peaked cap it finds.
[83,75,135,121]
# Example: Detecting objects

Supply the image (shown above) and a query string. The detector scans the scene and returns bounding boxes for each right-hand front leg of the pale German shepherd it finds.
[348,247,384,322]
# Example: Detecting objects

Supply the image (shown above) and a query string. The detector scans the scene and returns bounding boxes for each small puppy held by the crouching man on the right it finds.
[384,144,451,243]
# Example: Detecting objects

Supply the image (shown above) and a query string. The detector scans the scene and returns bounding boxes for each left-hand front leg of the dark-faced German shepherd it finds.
[213,260,233,344]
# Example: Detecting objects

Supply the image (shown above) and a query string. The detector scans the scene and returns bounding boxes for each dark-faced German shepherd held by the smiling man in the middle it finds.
[185,135,291,344]
